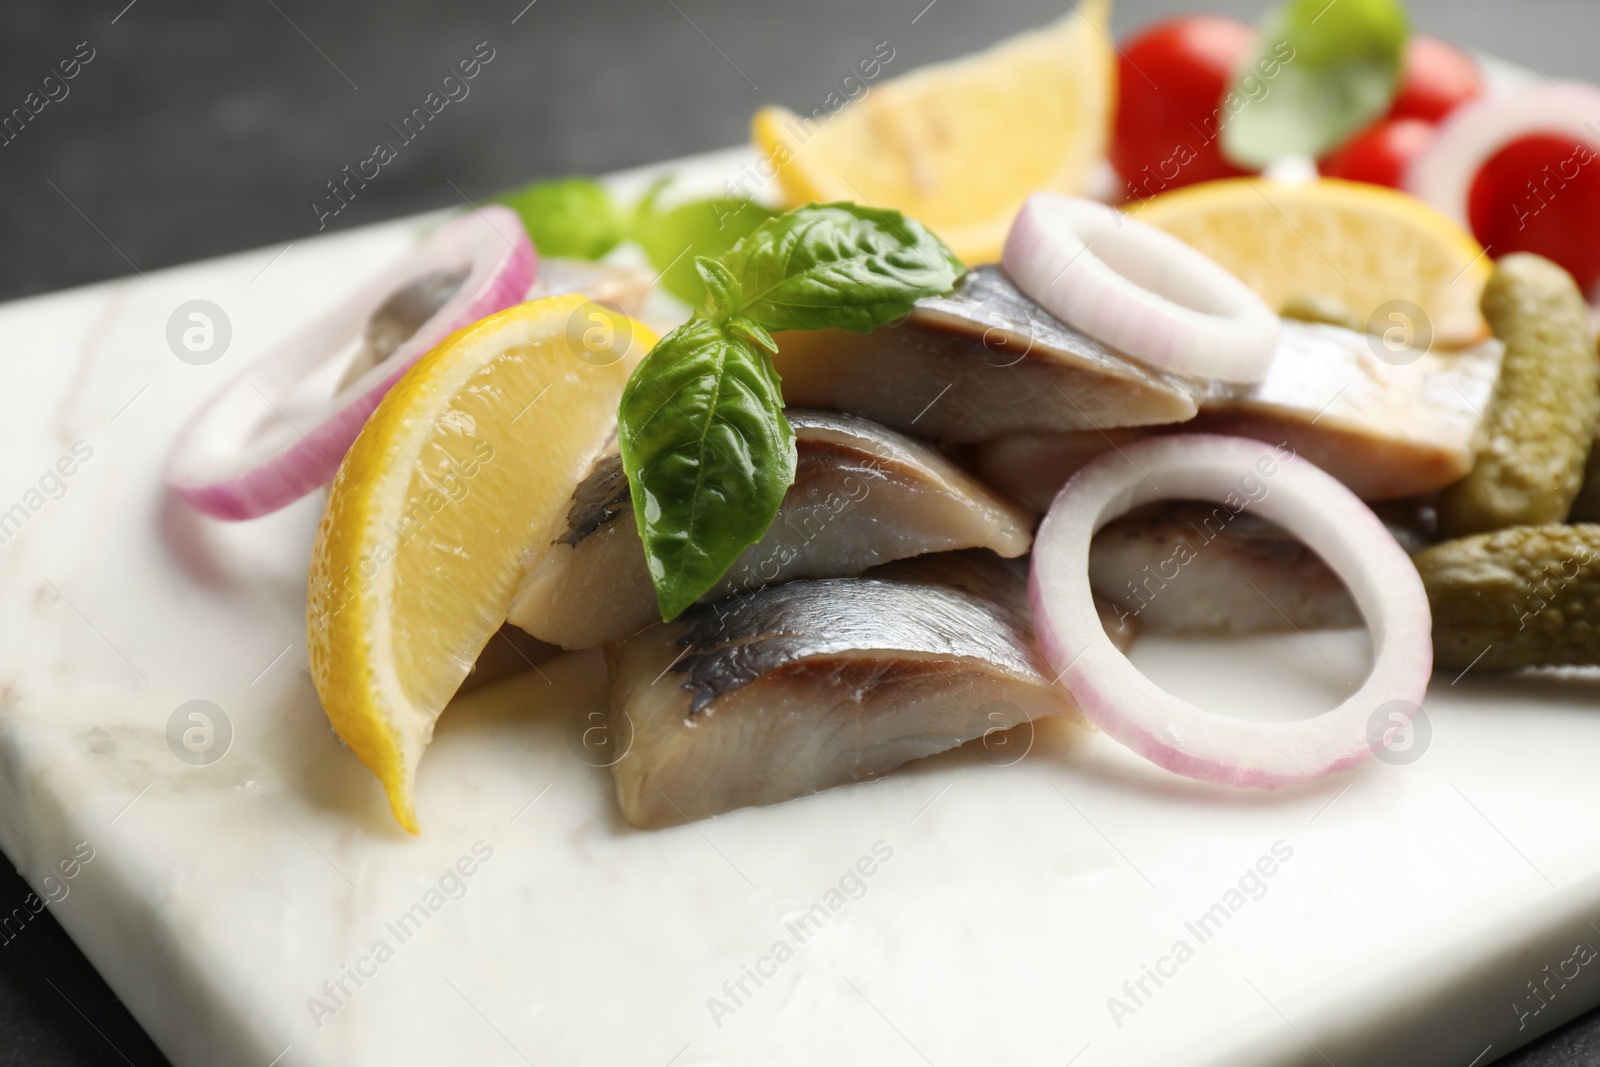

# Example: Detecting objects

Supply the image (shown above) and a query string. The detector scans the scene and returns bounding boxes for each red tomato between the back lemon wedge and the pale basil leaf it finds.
[1110,14,1256,198]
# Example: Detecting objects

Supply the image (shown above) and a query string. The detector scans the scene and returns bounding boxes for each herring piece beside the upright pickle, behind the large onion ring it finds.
[976,320,1504,512]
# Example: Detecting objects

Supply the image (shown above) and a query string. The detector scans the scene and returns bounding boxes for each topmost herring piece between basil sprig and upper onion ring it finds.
[773,266,1197,443]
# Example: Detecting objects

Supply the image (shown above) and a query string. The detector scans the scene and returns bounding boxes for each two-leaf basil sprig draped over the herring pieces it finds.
[618,203,965,619]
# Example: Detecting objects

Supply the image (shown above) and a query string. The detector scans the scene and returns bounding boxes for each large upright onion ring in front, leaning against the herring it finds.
[1029,434,1434,789]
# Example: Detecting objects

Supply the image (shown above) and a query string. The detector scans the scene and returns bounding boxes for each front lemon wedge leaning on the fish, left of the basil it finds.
[306,294,656,833]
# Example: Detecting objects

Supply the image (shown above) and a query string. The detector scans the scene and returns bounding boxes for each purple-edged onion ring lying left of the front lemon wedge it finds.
[166,206,536,520]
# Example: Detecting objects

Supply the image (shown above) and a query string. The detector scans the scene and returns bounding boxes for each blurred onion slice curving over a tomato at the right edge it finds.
[1405,82,1600,232]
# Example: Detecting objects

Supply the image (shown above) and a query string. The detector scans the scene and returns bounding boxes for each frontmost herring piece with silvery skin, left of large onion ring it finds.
[606,552,1133,827]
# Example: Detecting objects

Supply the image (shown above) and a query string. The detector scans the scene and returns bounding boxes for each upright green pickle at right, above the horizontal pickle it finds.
[1438,254,1600,536]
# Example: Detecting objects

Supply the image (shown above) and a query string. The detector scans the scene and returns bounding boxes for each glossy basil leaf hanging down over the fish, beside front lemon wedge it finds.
[618,315,795,619]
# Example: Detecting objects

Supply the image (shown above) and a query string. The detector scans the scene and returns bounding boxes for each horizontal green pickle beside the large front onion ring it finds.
[1416,523,1600,670]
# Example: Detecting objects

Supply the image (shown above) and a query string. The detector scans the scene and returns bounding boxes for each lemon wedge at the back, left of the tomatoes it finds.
[752,0,1115,262]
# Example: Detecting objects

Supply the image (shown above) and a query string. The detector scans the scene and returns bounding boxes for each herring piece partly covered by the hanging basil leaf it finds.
[509,410,1032,648]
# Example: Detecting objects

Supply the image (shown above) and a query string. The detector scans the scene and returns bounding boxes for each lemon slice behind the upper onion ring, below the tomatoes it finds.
[1128,178,1491,347]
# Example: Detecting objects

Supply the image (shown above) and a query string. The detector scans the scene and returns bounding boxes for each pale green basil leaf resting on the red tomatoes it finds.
[1222,0,1411,168]
